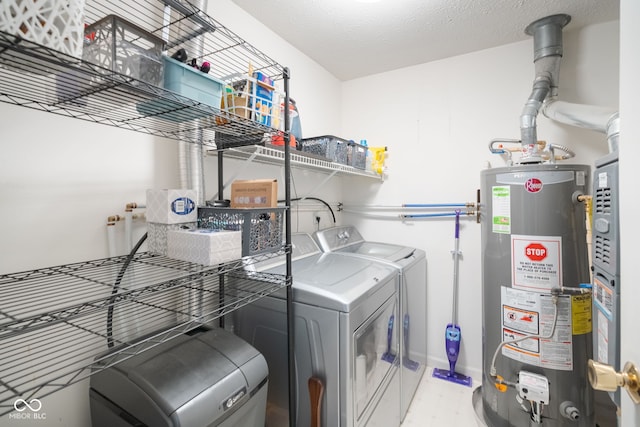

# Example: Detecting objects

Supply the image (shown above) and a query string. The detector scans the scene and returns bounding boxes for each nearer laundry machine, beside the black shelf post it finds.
[233,234,400,427]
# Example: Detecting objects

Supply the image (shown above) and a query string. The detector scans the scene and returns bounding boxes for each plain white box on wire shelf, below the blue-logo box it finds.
[167,228,242,266]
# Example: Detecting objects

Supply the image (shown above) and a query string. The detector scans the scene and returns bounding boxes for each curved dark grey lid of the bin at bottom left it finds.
[97,329,268,416]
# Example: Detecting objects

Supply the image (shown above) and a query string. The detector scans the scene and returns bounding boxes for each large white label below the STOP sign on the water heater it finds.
[501,286,573,371]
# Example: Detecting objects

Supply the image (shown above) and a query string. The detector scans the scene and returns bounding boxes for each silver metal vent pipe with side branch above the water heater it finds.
[520,14,620,163]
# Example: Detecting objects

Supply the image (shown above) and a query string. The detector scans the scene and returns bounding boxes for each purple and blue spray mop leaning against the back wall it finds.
[433,210,472,387]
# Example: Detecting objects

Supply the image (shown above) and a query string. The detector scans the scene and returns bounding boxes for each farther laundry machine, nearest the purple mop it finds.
[314,226,427,420]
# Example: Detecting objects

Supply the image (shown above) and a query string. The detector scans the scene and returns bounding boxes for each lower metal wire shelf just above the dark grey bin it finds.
[0,249,289,415]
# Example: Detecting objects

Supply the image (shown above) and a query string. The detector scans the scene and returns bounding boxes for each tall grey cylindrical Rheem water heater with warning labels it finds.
[481,164,595,427]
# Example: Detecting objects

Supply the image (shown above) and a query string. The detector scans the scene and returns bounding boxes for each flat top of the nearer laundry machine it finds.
[268,252,398,312]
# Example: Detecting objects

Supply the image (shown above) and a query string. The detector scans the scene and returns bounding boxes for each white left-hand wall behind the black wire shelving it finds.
[0,0,340,427]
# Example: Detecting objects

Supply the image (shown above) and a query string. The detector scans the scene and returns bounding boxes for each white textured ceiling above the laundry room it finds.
[233,0,620,80]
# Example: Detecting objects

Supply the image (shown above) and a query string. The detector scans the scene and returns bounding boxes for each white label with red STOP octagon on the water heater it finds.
[511,235,562,292]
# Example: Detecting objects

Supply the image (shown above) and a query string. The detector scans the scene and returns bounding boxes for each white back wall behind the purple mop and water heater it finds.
[342,22,619,378]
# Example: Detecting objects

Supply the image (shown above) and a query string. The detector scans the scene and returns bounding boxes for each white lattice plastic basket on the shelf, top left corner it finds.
[0,0,84,58]
